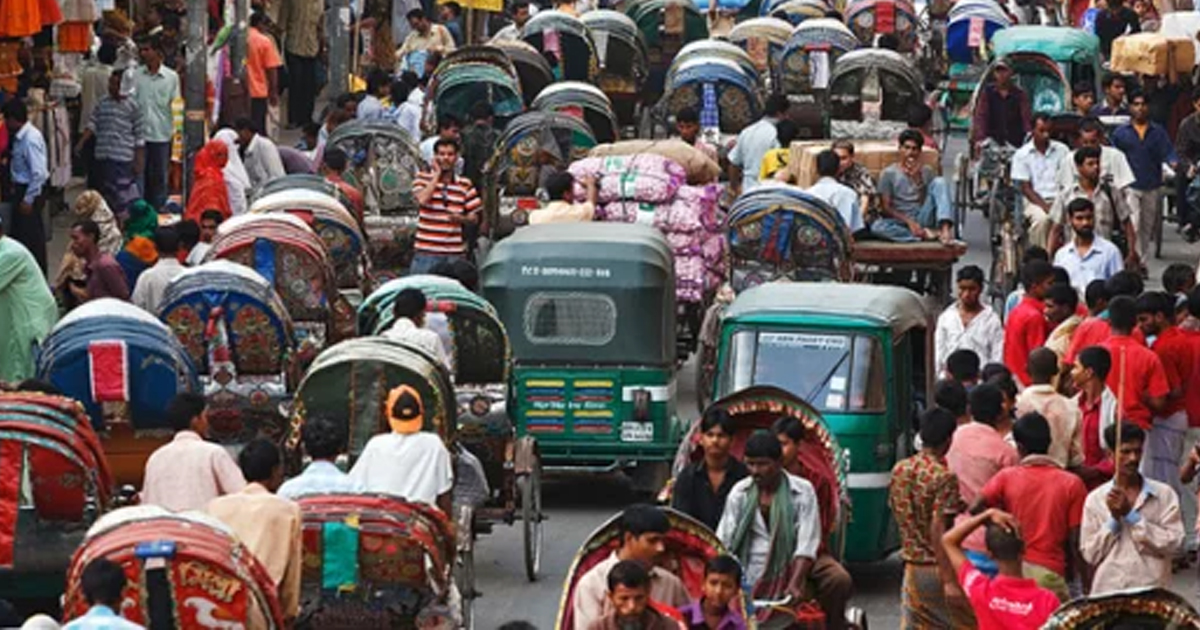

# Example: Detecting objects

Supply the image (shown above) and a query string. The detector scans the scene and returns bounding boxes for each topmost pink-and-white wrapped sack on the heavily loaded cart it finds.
[569,154,688,204]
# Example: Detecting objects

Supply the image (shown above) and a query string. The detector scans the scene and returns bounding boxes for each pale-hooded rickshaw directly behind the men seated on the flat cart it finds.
[828,48,925,140]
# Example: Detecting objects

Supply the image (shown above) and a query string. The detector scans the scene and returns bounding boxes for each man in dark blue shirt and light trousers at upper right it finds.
[1112,94,1180,276]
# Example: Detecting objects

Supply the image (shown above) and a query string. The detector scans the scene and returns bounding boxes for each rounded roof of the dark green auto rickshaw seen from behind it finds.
[480,222,674,279]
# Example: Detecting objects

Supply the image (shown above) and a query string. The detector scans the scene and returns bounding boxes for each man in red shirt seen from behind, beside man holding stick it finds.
[977,412,1087,601]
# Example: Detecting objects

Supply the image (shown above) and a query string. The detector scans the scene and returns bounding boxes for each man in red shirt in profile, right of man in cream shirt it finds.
[1070,346,1117,491]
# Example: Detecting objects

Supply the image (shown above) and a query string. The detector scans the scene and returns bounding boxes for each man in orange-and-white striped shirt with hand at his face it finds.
[409,138,482,274]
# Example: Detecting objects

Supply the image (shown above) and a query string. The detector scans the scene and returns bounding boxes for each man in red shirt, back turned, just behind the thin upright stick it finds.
[1100,295,1178,429]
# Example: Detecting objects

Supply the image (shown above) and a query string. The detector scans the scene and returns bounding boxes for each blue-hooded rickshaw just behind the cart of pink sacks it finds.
[658,53,762,134]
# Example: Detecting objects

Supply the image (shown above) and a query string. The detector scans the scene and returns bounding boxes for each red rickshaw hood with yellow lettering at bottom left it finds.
[62,505,286,630]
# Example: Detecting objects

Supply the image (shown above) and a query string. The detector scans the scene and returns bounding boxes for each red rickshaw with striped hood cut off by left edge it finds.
[0,391,115,600]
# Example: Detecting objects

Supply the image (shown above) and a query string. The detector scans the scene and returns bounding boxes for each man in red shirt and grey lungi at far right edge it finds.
[1136,292,1196,496]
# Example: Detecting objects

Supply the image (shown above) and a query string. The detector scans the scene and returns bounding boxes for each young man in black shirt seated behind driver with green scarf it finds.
[671,407,750,529]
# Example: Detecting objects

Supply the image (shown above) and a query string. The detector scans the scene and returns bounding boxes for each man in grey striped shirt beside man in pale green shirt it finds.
[76,70,146,212]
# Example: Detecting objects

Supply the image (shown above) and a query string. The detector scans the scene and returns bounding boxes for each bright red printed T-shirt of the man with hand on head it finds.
[959,562,1058,630]
